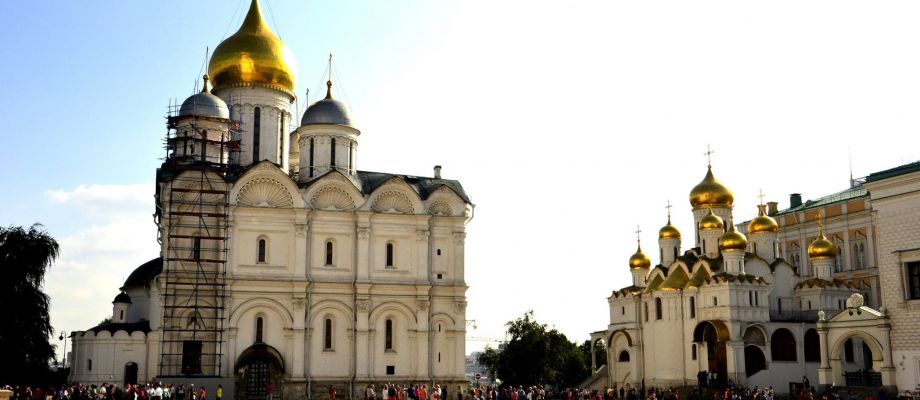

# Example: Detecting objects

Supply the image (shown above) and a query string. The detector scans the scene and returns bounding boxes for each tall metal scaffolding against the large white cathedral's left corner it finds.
[156,104,240,377]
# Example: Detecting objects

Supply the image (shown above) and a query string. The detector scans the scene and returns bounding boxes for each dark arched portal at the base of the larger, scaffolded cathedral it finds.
[235,343,284,400]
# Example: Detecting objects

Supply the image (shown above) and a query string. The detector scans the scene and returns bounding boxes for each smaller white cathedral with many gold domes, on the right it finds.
[591,165,904,393]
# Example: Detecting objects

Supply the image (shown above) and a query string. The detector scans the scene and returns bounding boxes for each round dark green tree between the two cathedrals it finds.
[477,311,590,387]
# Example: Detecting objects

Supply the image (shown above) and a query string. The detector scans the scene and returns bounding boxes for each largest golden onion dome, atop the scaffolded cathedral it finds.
[208,0,294,99]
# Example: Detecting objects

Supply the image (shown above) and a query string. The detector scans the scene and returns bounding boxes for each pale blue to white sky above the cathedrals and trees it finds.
[0,0,920,360]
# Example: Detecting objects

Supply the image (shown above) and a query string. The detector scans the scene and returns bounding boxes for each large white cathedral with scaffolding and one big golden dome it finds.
[69,0,473,399]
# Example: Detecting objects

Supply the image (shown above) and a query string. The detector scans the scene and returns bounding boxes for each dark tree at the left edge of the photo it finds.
[0,224,60,383]
